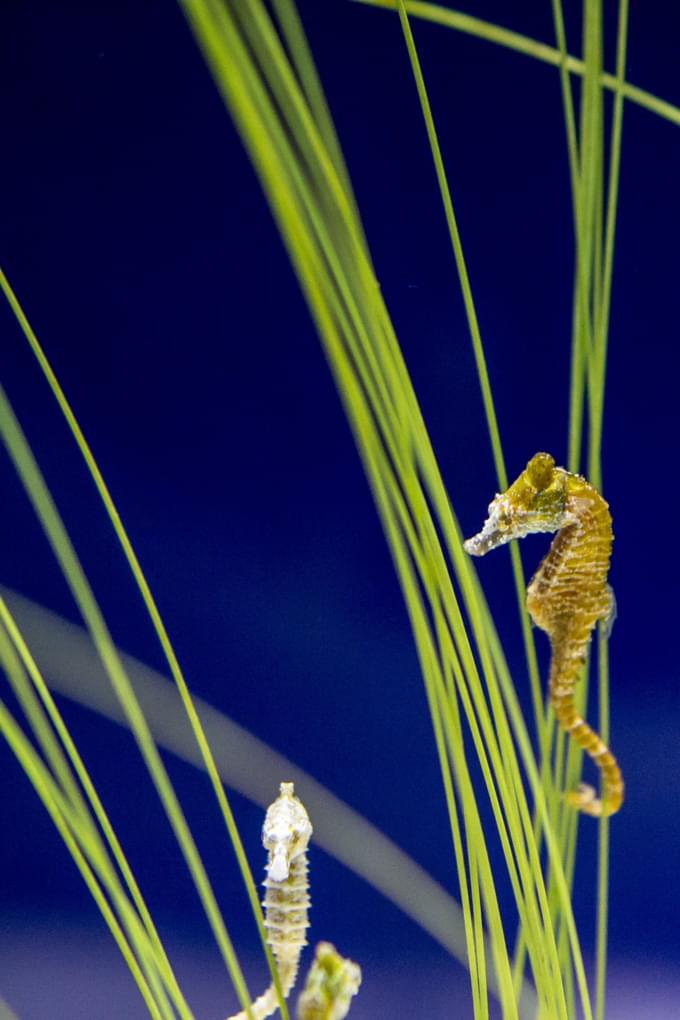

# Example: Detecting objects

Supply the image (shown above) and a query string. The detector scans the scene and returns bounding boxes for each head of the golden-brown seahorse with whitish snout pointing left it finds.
[463,453,571,556]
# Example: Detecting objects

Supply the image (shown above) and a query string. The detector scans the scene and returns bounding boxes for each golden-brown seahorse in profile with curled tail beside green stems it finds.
[464,453,624,816]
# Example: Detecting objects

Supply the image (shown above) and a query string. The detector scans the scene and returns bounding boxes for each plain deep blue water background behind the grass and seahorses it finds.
[0,0,680,1020]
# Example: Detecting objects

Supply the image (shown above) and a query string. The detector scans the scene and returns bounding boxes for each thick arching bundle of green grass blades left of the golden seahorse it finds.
[180,4,599,1015]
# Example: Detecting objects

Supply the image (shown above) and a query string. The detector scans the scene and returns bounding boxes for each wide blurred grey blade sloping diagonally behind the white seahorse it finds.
[0,587,534,1016]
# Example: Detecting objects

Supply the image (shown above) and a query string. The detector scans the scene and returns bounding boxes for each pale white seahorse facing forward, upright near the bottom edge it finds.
[229,782,312,1020]
